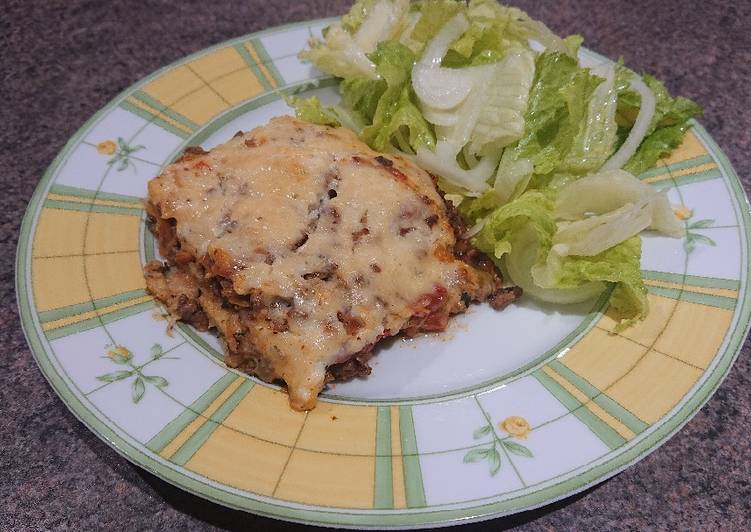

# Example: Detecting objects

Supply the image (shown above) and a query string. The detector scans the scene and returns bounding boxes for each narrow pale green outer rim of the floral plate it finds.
[14,17,751,529]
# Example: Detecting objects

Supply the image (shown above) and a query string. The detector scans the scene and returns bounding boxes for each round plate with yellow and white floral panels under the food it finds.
[16,16,749,528]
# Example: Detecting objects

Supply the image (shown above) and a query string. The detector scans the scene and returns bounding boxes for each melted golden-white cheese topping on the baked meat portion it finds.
[149,117,469,409]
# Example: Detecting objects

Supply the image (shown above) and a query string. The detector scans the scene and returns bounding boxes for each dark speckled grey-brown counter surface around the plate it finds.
[0,0,751,530]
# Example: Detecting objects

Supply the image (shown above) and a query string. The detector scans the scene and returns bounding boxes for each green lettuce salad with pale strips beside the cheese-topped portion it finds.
[290,0,701,328]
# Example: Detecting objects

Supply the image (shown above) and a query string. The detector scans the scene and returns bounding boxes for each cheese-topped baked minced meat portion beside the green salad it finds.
[145,117,520,410]
